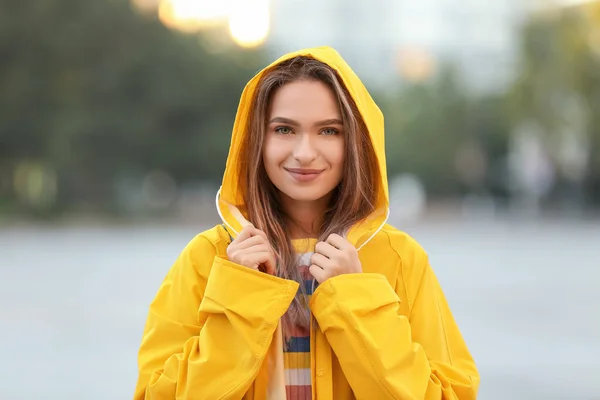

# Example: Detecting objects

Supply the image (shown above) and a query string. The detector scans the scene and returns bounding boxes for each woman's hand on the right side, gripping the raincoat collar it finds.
[309,233,362,283]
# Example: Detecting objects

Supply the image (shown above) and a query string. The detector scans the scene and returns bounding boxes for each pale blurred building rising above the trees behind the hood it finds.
[268,0,528,92]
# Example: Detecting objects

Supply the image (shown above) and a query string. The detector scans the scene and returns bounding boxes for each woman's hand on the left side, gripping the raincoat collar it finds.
[227,225,276,275]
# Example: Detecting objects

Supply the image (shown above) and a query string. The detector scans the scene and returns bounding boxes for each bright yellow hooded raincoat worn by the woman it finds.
[134,47,479,400]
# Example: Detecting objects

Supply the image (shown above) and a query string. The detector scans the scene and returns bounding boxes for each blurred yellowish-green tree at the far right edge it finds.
[509,2,600,205]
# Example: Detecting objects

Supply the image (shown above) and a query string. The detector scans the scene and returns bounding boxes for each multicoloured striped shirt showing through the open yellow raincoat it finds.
[283,245,315,400]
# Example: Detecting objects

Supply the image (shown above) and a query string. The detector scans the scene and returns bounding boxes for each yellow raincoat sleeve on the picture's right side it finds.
[311,236,479,400]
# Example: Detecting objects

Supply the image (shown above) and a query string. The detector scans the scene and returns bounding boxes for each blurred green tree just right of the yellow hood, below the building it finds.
[380,63,508,198]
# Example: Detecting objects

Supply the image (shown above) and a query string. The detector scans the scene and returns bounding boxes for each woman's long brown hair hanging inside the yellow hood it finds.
[238,56,381,337]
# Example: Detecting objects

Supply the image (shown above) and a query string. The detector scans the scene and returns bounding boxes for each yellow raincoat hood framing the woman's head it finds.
[216,46,389,248]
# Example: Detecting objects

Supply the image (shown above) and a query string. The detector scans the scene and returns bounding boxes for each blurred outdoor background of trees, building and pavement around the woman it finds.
[0,0,600,400]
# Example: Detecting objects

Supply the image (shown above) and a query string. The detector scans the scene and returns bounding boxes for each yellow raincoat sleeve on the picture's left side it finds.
[134,235,298,400]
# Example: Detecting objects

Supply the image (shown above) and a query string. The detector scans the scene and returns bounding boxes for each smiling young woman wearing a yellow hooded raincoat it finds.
[134,47,479,400]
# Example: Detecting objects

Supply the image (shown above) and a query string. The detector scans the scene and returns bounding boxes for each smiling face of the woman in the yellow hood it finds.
[263,80,344,208]
